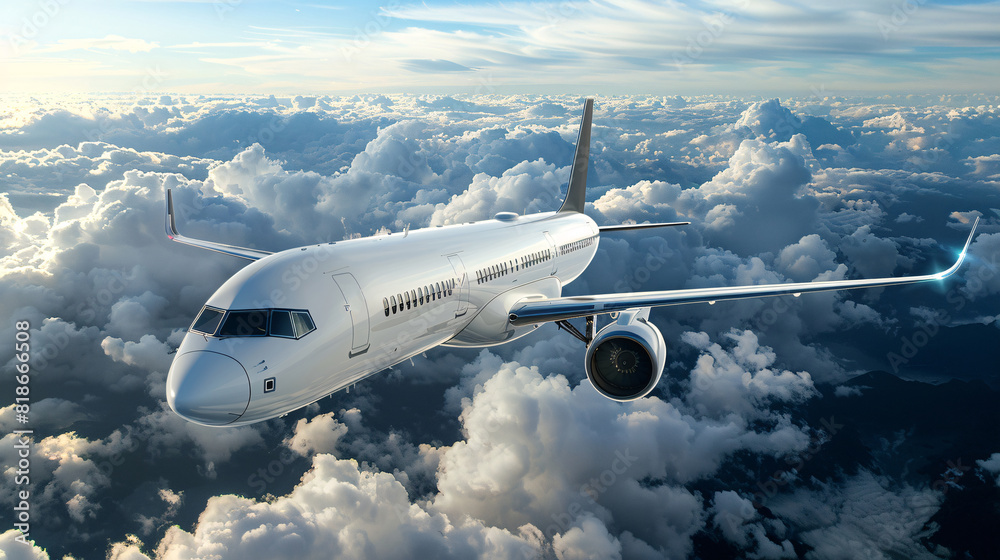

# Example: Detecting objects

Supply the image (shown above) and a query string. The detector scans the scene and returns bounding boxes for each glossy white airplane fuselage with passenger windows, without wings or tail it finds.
[167,212,599,426]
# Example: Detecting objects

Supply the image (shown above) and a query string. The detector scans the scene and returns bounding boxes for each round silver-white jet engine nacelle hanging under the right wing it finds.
[584,307,667,402]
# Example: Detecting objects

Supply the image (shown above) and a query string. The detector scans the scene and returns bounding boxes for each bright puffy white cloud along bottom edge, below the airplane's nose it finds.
[147,455,541,559]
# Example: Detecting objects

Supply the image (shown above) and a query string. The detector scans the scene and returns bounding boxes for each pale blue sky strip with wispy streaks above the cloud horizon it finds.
[0,0,1000,95]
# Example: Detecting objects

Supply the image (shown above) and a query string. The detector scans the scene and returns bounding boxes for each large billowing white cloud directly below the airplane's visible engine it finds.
[425,355,807,556]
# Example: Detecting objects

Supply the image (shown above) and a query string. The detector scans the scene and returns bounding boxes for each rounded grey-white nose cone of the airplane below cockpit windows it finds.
[167,351,250,426]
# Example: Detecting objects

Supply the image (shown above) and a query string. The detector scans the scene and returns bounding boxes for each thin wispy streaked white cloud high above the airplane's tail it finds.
[374,2,1000,90]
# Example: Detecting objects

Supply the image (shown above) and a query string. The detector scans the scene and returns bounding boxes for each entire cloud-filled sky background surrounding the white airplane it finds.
[0,0,1000,560]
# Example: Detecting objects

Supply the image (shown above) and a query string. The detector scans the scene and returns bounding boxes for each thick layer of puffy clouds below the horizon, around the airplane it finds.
[0,95,1000,558]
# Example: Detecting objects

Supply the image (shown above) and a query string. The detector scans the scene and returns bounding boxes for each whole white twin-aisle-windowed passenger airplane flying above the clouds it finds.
[165,99,979,426]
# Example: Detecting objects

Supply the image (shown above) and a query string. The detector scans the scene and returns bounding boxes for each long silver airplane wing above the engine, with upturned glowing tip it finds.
[509,218,979,327]
